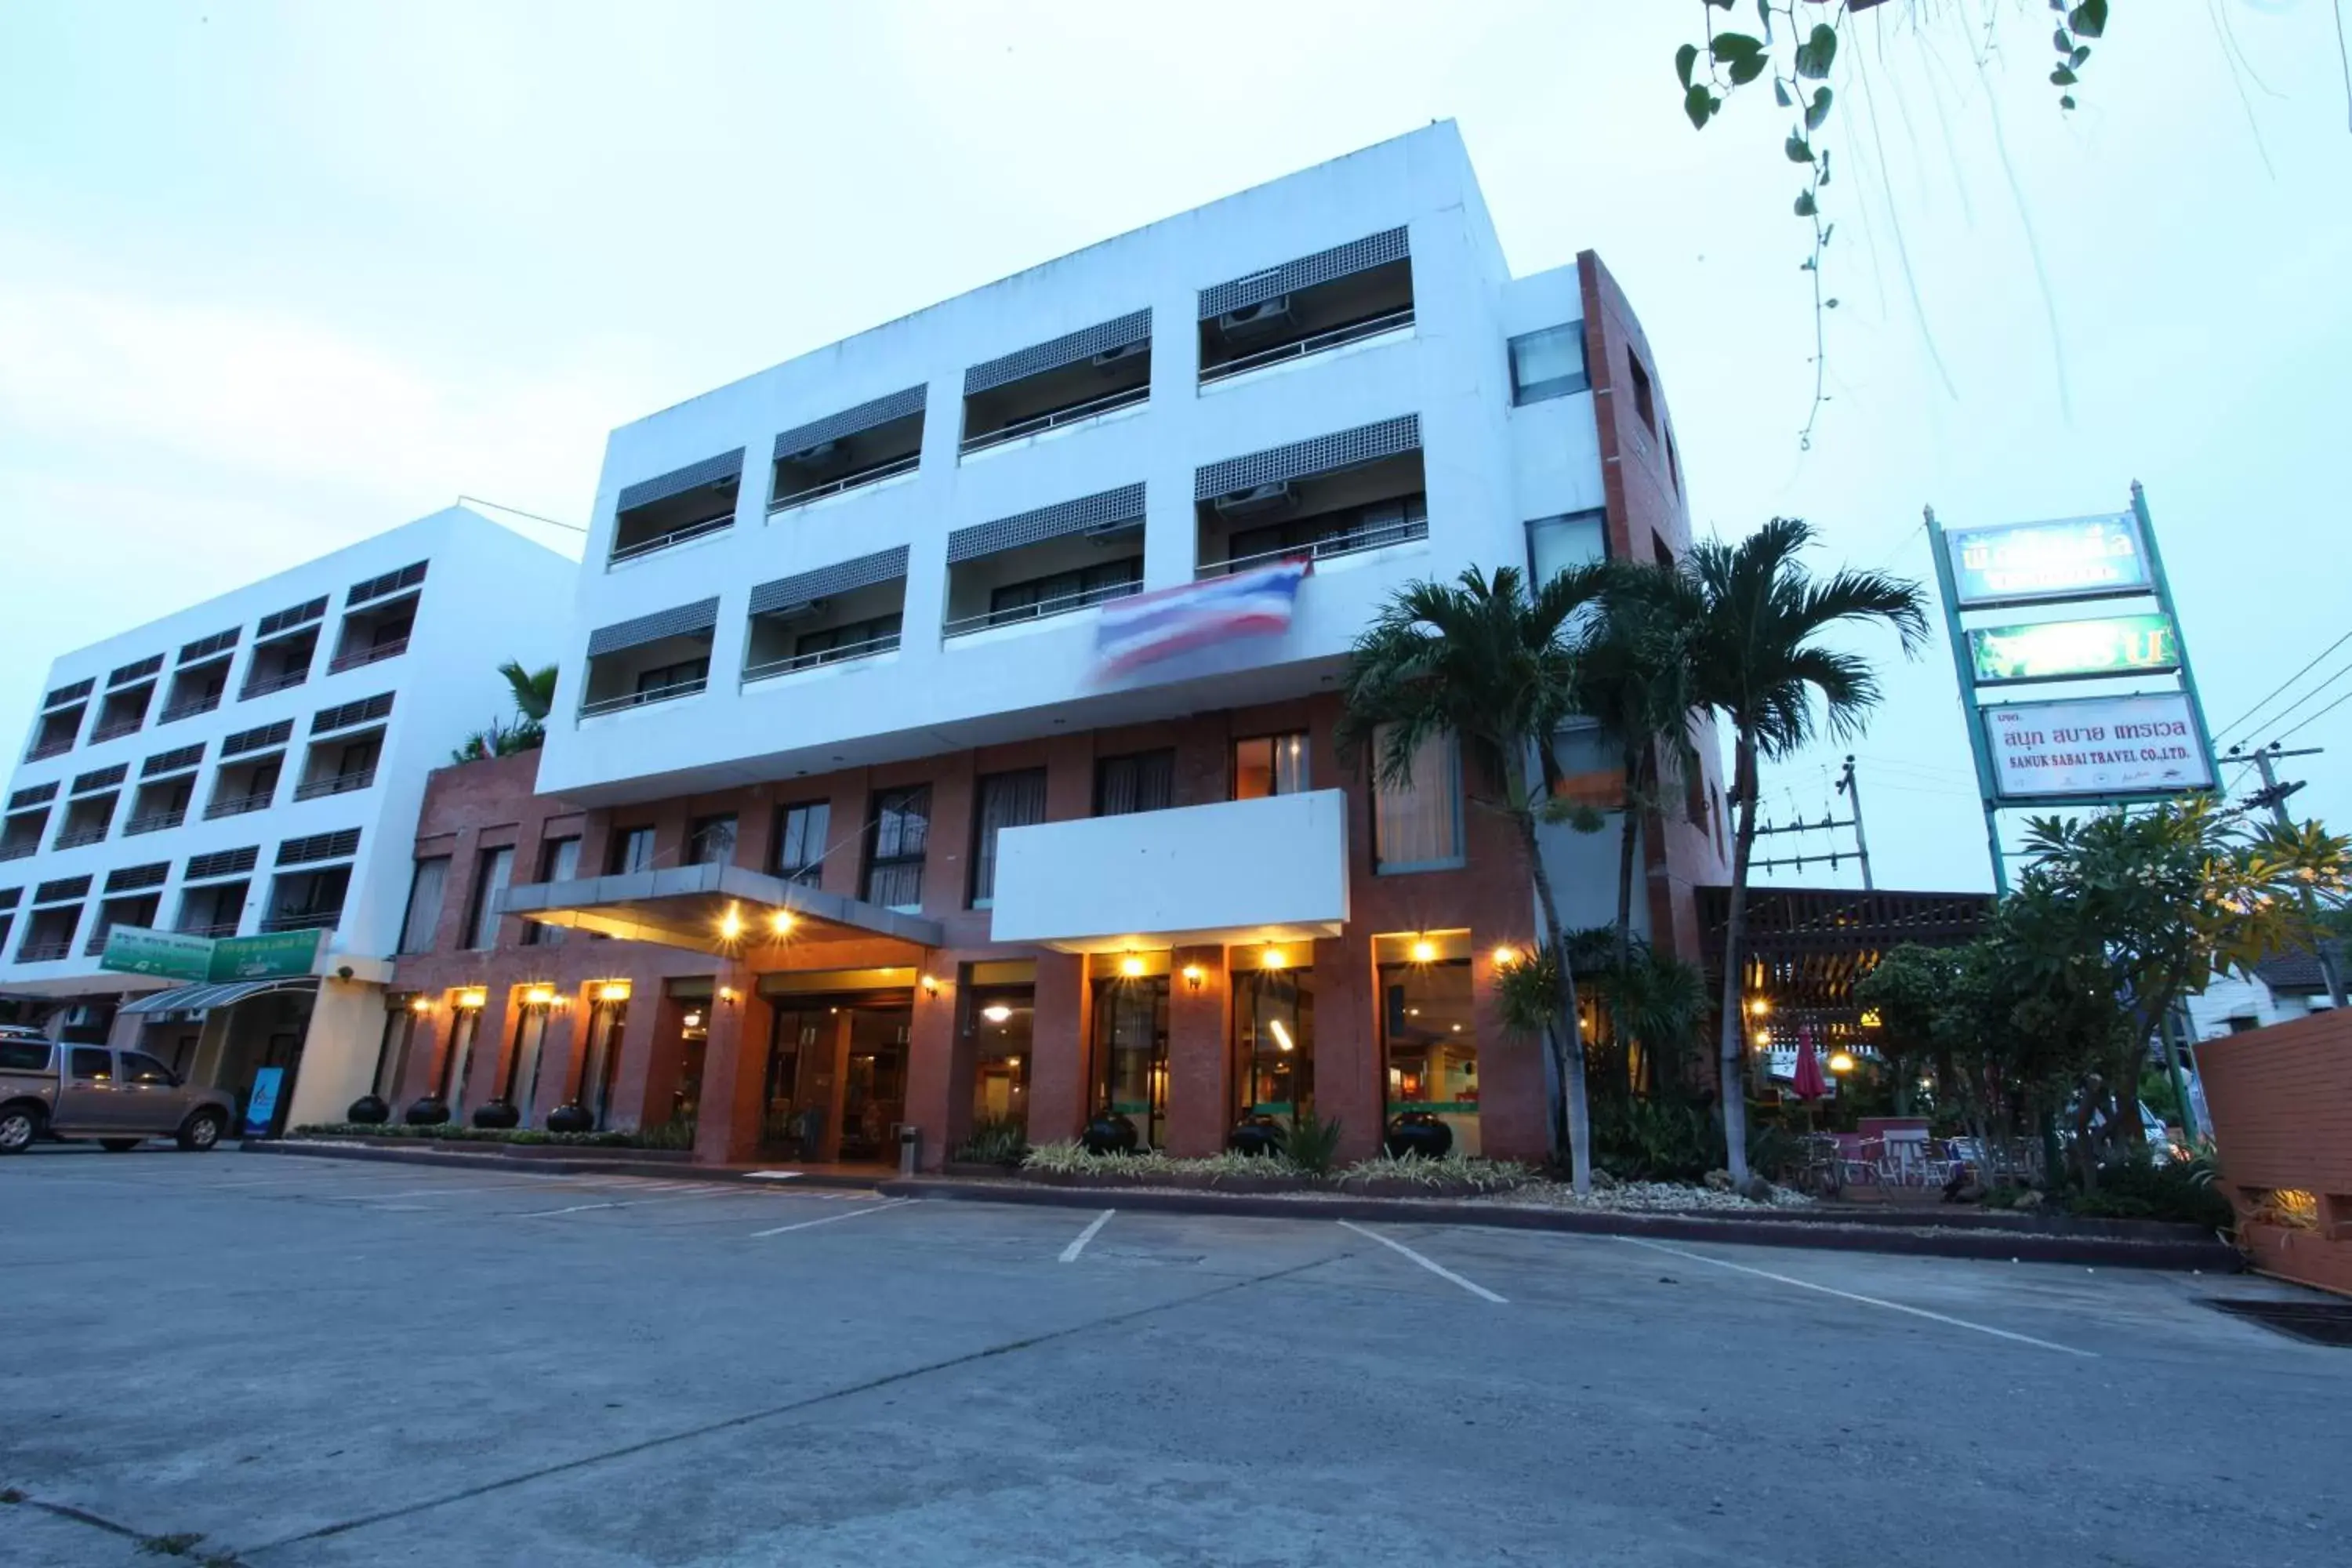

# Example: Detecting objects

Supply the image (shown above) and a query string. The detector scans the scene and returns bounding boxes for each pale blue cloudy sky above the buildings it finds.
[0,0,2352,888]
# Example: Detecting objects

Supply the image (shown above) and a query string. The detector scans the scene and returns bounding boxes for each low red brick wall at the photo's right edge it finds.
[2197,1011,2352,1295]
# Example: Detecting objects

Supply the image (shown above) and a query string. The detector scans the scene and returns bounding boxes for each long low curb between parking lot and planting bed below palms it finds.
[877,1178,2246,1274]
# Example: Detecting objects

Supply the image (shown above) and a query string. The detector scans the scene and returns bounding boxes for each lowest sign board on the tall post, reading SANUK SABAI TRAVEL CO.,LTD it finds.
[1978,691,2213,801]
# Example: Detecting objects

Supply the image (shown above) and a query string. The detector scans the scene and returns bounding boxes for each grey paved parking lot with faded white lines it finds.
[0,1149,2352,1568]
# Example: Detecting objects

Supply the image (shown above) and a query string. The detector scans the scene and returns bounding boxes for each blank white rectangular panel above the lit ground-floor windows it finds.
[990,789,1348,952]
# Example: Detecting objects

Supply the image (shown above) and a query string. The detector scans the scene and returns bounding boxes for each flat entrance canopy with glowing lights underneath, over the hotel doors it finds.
[501,865,948,956]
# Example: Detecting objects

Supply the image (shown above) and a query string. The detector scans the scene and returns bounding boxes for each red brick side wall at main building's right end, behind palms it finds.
[1576,252,1731,961]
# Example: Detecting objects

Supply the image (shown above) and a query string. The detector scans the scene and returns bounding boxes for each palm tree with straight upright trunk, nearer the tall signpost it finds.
[1682,517,1926,1185]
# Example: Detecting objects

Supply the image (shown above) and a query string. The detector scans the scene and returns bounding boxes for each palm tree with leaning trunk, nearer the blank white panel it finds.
[1338,567,1606,1192]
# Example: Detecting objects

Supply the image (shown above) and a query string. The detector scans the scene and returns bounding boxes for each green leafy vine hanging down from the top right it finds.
[1675,0,2107,452]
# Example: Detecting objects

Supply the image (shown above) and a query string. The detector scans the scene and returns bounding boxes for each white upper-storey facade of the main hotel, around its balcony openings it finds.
[541,122,1604,804]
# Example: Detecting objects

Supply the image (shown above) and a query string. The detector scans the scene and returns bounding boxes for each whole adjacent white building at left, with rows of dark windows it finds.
[0,508,574,1121]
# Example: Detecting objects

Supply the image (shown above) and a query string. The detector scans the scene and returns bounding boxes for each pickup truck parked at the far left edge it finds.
[0,1027,235,1154]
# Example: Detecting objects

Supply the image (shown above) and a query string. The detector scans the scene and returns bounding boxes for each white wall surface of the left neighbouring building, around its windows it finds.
[0,508,572,1011]
